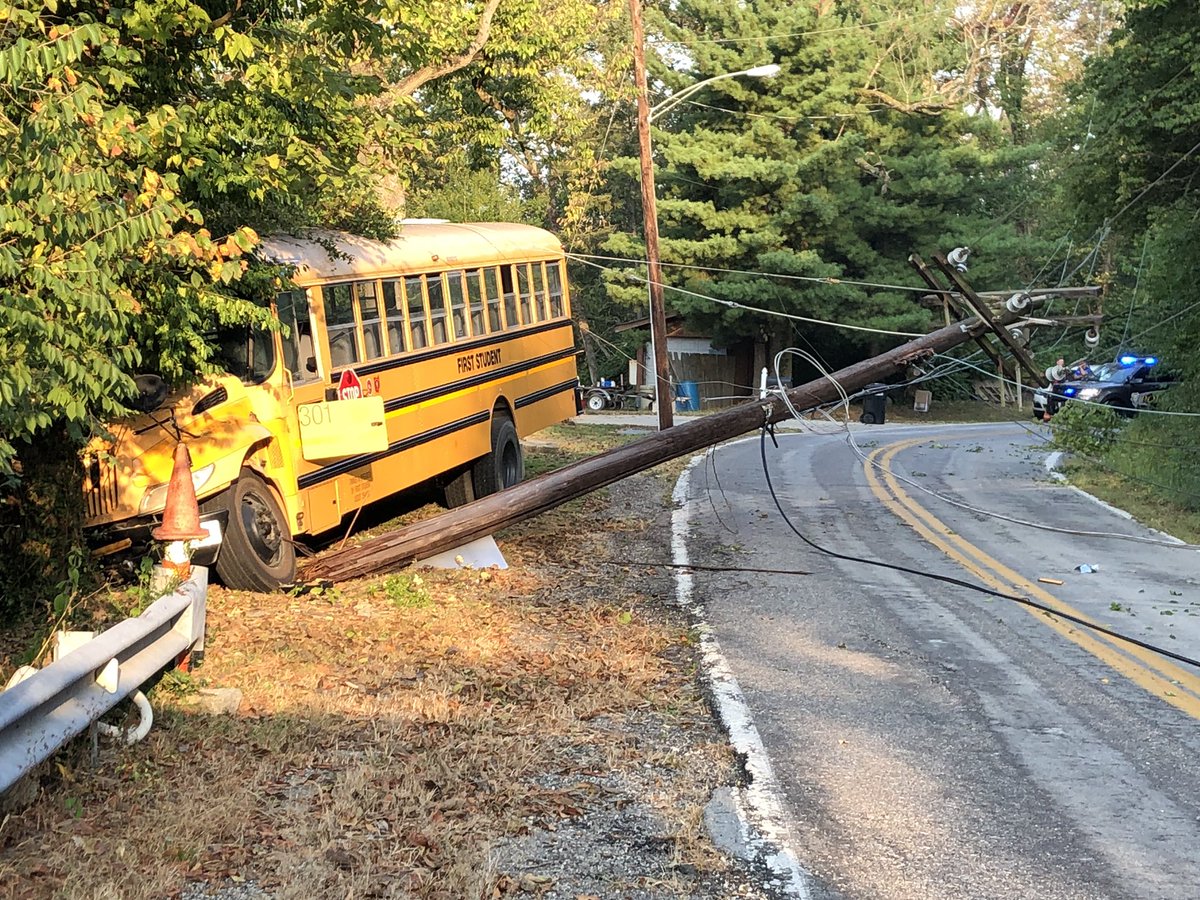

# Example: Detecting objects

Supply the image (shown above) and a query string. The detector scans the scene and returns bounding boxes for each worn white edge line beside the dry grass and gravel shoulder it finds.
[671,452,810,900]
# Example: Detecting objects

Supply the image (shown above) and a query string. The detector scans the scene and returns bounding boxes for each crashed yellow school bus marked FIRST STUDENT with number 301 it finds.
[84,222,577,590]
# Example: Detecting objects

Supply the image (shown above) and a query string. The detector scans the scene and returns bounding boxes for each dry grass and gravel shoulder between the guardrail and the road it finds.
[0,428,769,900]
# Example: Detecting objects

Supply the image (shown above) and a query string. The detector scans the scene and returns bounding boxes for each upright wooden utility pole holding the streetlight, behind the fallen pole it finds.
[629,0,674,431]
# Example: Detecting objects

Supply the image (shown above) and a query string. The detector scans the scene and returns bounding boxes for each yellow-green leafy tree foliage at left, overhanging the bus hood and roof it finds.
[0,0,600,607]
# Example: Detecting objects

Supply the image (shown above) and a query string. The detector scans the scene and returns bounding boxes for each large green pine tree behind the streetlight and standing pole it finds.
[608,0,1046,369]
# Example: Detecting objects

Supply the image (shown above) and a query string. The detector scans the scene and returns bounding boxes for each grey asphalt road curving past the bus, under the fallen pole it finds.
[686,425,1200,900]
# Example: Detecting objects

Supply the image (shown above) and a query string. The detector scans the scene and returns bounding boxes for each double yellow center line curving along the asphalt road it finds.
[863,436,1200,719]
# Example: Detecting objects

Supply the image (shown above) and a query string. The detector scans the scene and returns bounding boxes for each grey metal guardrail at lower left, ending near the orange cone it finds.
[0,566,209,793]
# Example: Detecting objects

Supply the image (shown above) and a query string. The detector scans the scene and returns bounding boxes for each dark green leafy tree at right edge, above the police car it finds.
[1055,2,1200,379]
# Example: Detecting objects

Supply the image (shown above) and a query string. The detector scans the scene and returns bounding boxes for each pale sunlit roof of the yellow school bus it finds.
[259,222,563,284]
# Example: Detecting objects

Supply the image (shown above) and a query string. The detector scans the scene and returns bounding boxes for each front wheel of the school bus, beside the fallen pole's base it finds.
[204,470,296,592]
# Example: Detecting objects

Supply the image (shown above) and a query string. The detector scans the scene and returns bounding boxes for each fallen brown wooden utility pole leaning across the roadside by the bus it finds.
[302,303,1032,582]
